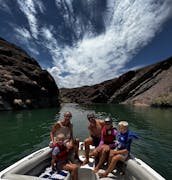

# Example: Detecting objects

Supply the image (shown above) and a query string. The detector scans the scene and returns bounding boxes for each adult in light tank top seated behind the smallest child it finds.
[50,111,79,160]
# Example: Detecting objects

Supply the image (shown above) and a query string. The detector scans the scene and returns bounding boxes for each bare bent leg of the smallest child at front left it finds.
[61,163,78,180]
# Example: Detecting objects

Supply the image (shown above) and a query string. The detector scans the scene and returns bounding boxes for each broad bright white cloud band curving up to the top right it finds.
[48,0,172,87]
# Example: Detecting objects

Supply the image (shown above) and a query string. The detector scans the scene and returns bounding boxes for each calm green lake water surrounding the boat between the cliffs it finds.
[0,104,172,179]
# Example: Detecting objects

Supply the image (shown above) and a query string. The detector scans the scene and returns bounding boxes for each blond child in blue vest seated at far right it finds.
[98,121,138,177]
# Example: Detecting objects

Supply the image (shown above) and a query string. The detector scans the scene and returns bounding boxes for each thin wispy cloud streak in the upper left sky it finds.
[13,0,45,56]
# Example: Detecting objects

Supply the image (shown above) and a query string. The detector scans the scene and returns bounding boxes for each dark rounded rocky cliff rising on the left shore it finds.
[0,38,59,110]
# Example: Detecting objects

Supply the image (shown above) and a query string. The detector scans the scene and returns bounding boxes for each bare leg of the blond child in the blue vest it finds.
[98,154,123,177]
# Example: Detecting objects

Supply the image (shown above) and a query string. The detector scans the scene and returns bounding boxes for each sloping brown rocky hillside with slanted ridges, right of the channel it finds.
[60,58,172,106]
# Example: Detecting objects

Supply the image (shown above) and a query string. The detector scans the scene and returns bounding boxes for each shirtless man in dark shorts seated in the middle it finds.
[83,114,105,165]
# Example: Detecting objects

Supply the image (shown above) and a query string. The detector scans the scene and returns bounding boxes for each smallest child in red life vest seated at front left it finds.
[51,134,78,180]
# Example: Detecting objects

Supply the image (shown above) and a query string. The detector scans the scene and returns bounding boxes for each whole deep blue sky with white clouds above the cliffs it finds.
[0,0,172,88]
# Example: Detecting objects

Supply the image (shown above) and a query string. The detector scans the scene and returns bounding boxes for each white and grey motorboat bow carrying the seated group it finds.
[0,143,165,180]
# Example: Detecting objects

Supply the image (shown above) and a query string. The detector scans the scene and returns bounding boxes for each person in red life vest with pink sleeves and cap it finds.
[89,117,118,173]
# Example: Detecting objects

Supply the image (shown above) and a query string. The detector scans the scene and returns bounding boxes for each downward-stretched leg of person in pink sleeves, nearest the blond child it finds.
[93,145,110,173]
